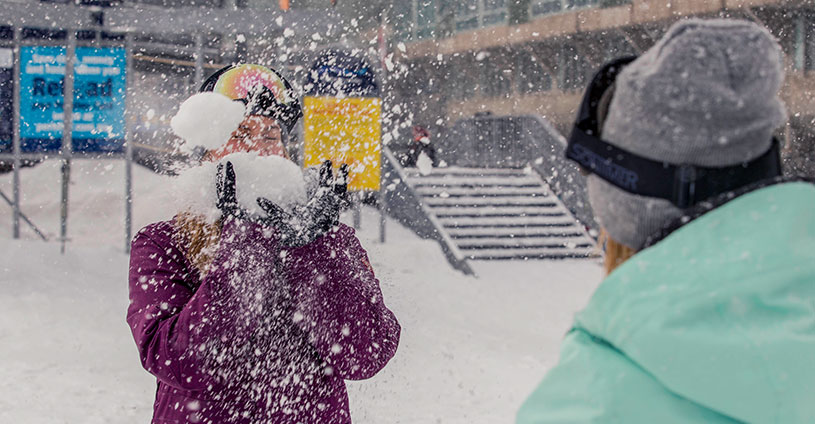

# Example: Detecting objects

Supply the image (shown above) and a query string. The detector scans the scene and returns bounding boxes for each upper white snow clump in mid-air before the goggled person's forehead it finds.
[170,92,246,150]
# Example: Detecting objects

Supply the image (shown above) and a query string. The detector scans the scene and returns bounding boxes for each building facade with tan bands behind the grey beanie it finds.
[389,0,815,176]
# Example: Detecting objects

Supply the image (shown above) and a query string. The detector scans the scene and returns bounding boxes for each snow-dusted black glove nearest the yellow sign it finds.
[257,160,348,247]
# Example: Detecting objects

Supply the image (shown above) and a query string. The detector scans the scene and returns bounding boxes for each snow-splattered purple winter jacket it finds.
[127,220,400,424]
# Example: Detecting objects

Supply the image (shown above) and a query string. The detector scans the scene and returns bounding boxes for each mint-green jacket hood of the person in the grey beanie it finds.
[575,182,815,422]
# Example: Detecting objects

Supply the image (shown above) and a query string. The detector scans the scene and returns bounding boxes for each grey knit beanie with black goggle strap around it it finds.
[587,19,786,250]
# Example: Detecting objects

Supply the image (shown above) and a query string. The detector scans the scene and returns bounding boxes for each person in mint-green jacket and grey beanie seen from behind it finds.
[517,19,815,424]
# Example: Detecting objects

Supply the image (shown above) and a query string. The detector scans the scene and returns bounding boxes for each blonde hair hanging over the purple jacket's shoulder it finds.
[173,212,221,278]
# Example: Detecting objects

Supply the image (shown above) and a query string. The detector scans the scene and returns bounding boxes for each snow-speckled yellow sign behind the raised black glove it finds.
[303,97,382,191]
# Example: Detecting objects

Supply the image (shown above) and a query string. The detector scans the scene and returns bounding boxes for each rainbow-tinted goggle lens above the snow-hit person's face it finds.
[212,64,292,105]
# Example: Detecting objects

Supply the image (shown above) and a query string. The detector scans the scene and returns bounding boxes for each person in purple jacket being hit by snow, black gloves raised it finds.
[127,65,400,424]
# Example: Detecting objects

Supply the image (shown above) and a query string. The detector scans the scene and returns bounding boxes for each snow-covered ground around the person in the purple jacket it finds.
[0,161,601,424]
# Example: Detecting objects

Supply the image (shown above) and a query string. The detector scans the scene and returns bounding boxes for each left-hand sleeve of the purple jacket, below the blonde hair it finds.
[127,221,275,390]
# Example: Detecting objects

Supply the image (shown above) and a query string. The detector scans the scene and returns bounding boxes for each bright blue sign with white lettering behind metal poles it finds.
[20,47,127,152]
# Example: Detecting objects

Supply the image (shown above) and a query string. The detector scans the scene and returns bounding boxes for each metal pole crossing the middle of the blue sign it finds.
[60,29,76,253]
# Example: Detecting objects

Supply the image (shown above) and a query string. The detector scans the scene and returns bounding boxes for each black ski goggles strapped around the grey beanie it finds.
[566,56,781,209]
